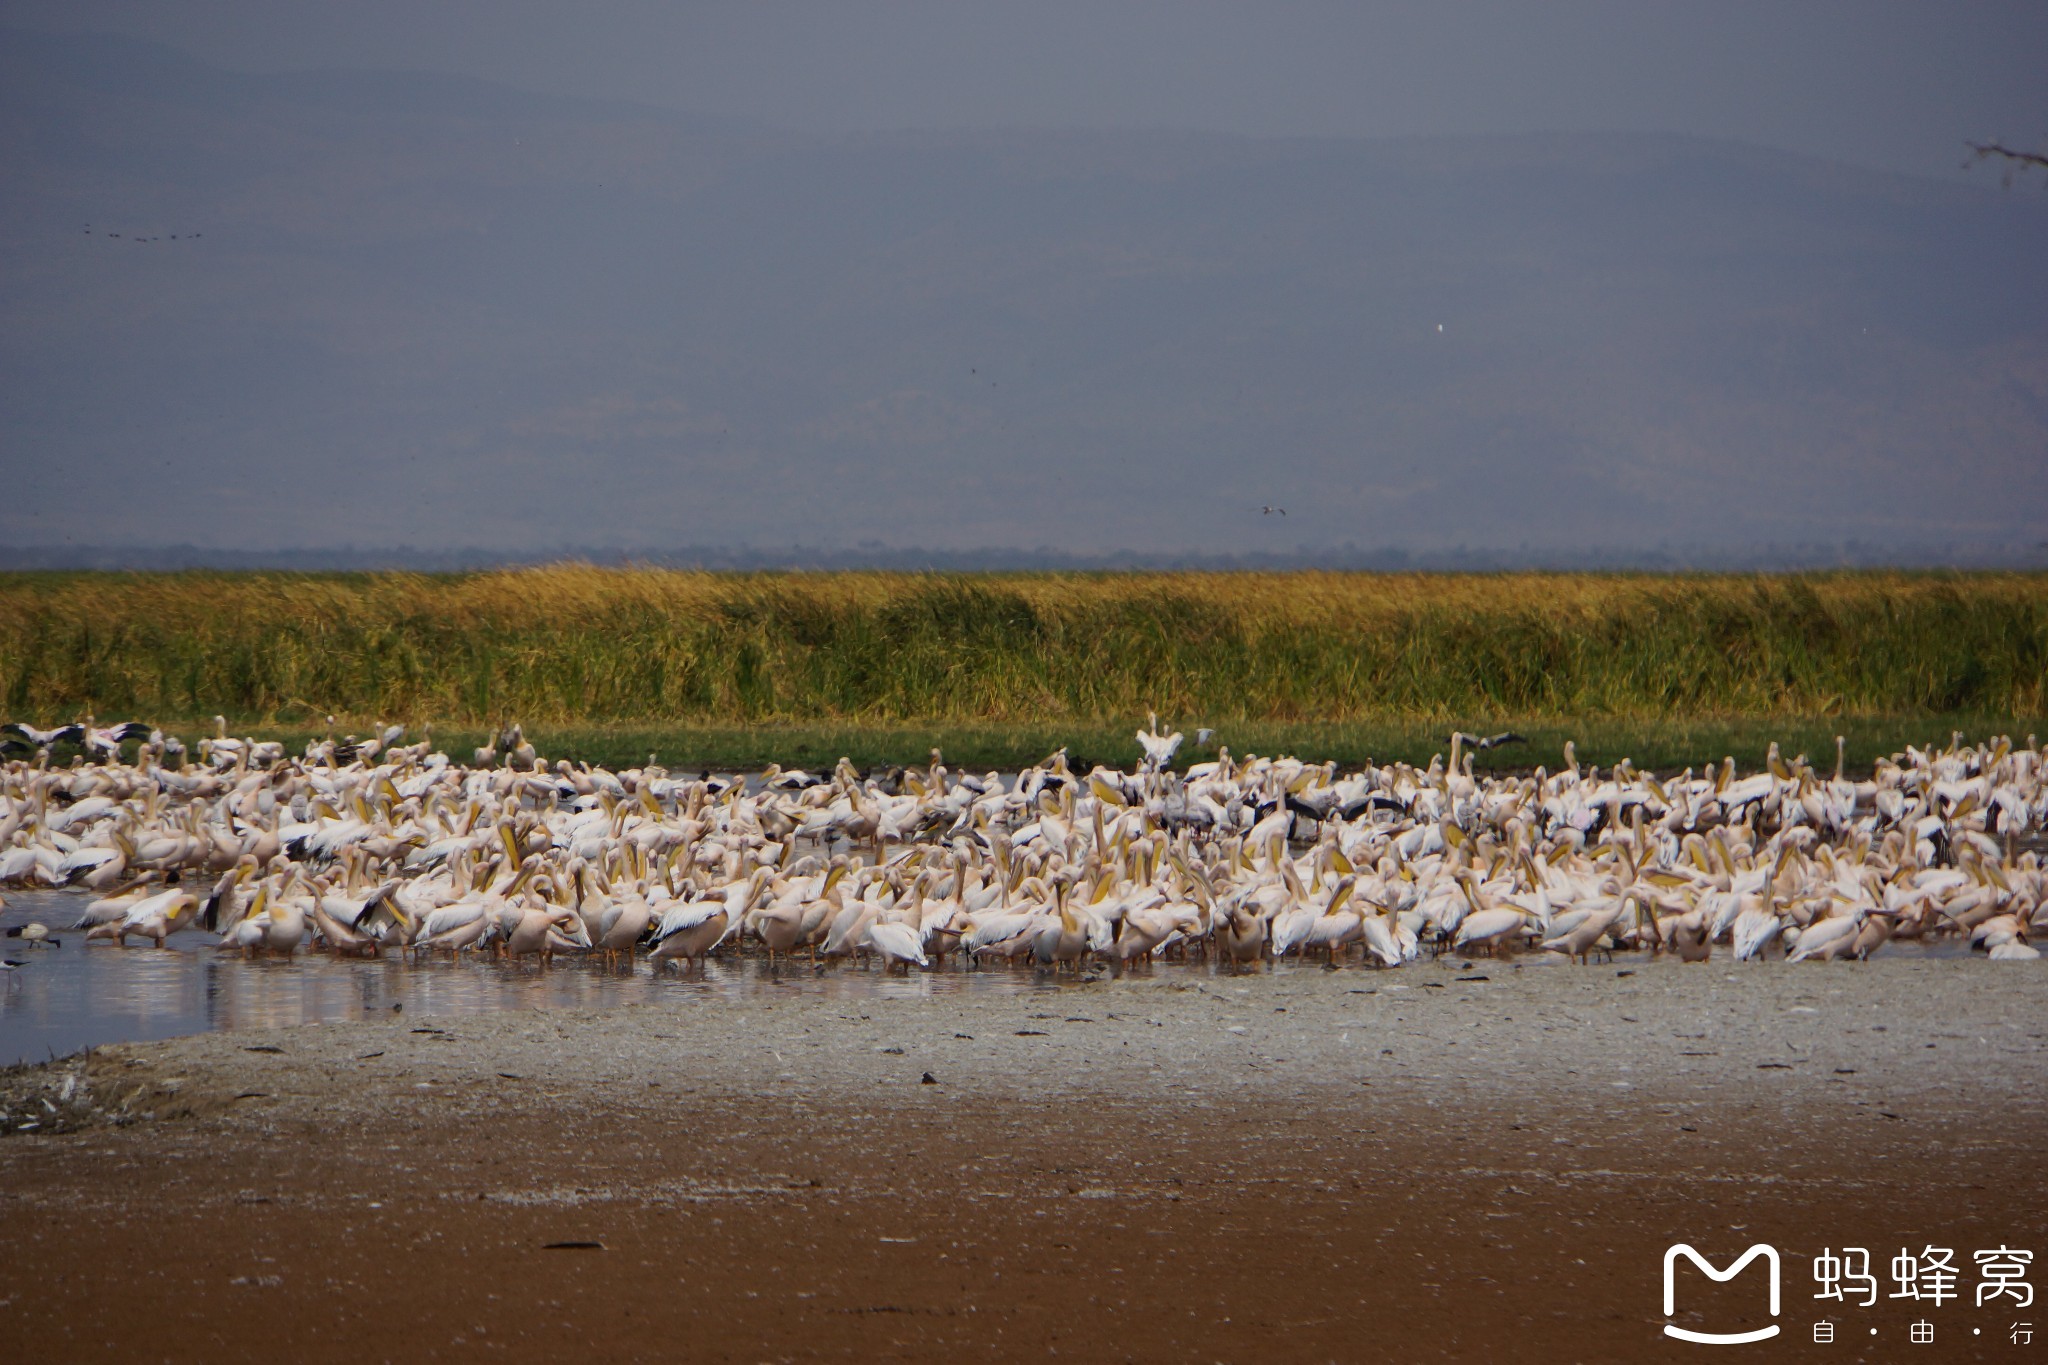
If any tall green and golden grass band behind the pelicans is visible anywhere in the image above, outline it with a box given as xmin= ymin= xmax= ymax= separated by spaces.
xmin=0 ymin=565 xmax=2048 ymax=740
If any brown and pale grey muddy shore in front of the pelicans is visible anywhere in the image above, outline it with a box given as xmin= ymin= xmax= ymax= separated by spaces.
xmin=0 ymin=960 xmax=2048 ymax=1361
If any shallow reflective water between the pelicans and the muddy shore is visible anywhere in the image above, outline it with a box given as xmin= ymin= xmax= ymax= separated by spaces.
xmin=0 ymin=890 xmax=1995 ymax=1066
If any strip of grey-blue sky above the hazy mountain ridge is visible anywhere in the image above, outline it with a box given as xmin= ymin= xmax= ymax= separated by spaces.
xmin=0 ymin=0 xmax=2048 ymax=176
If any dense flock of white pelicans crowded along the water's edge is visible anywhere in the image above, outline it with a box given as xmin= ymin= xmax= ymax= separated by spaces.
xmin=0 ymin=718 xmax=2048 ymax=972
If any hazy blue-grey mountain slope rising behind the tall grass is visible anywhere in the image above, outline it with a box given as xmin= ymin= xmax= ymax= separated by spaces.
xmin=0 ymin=31 xmax=2048 ymax=557
